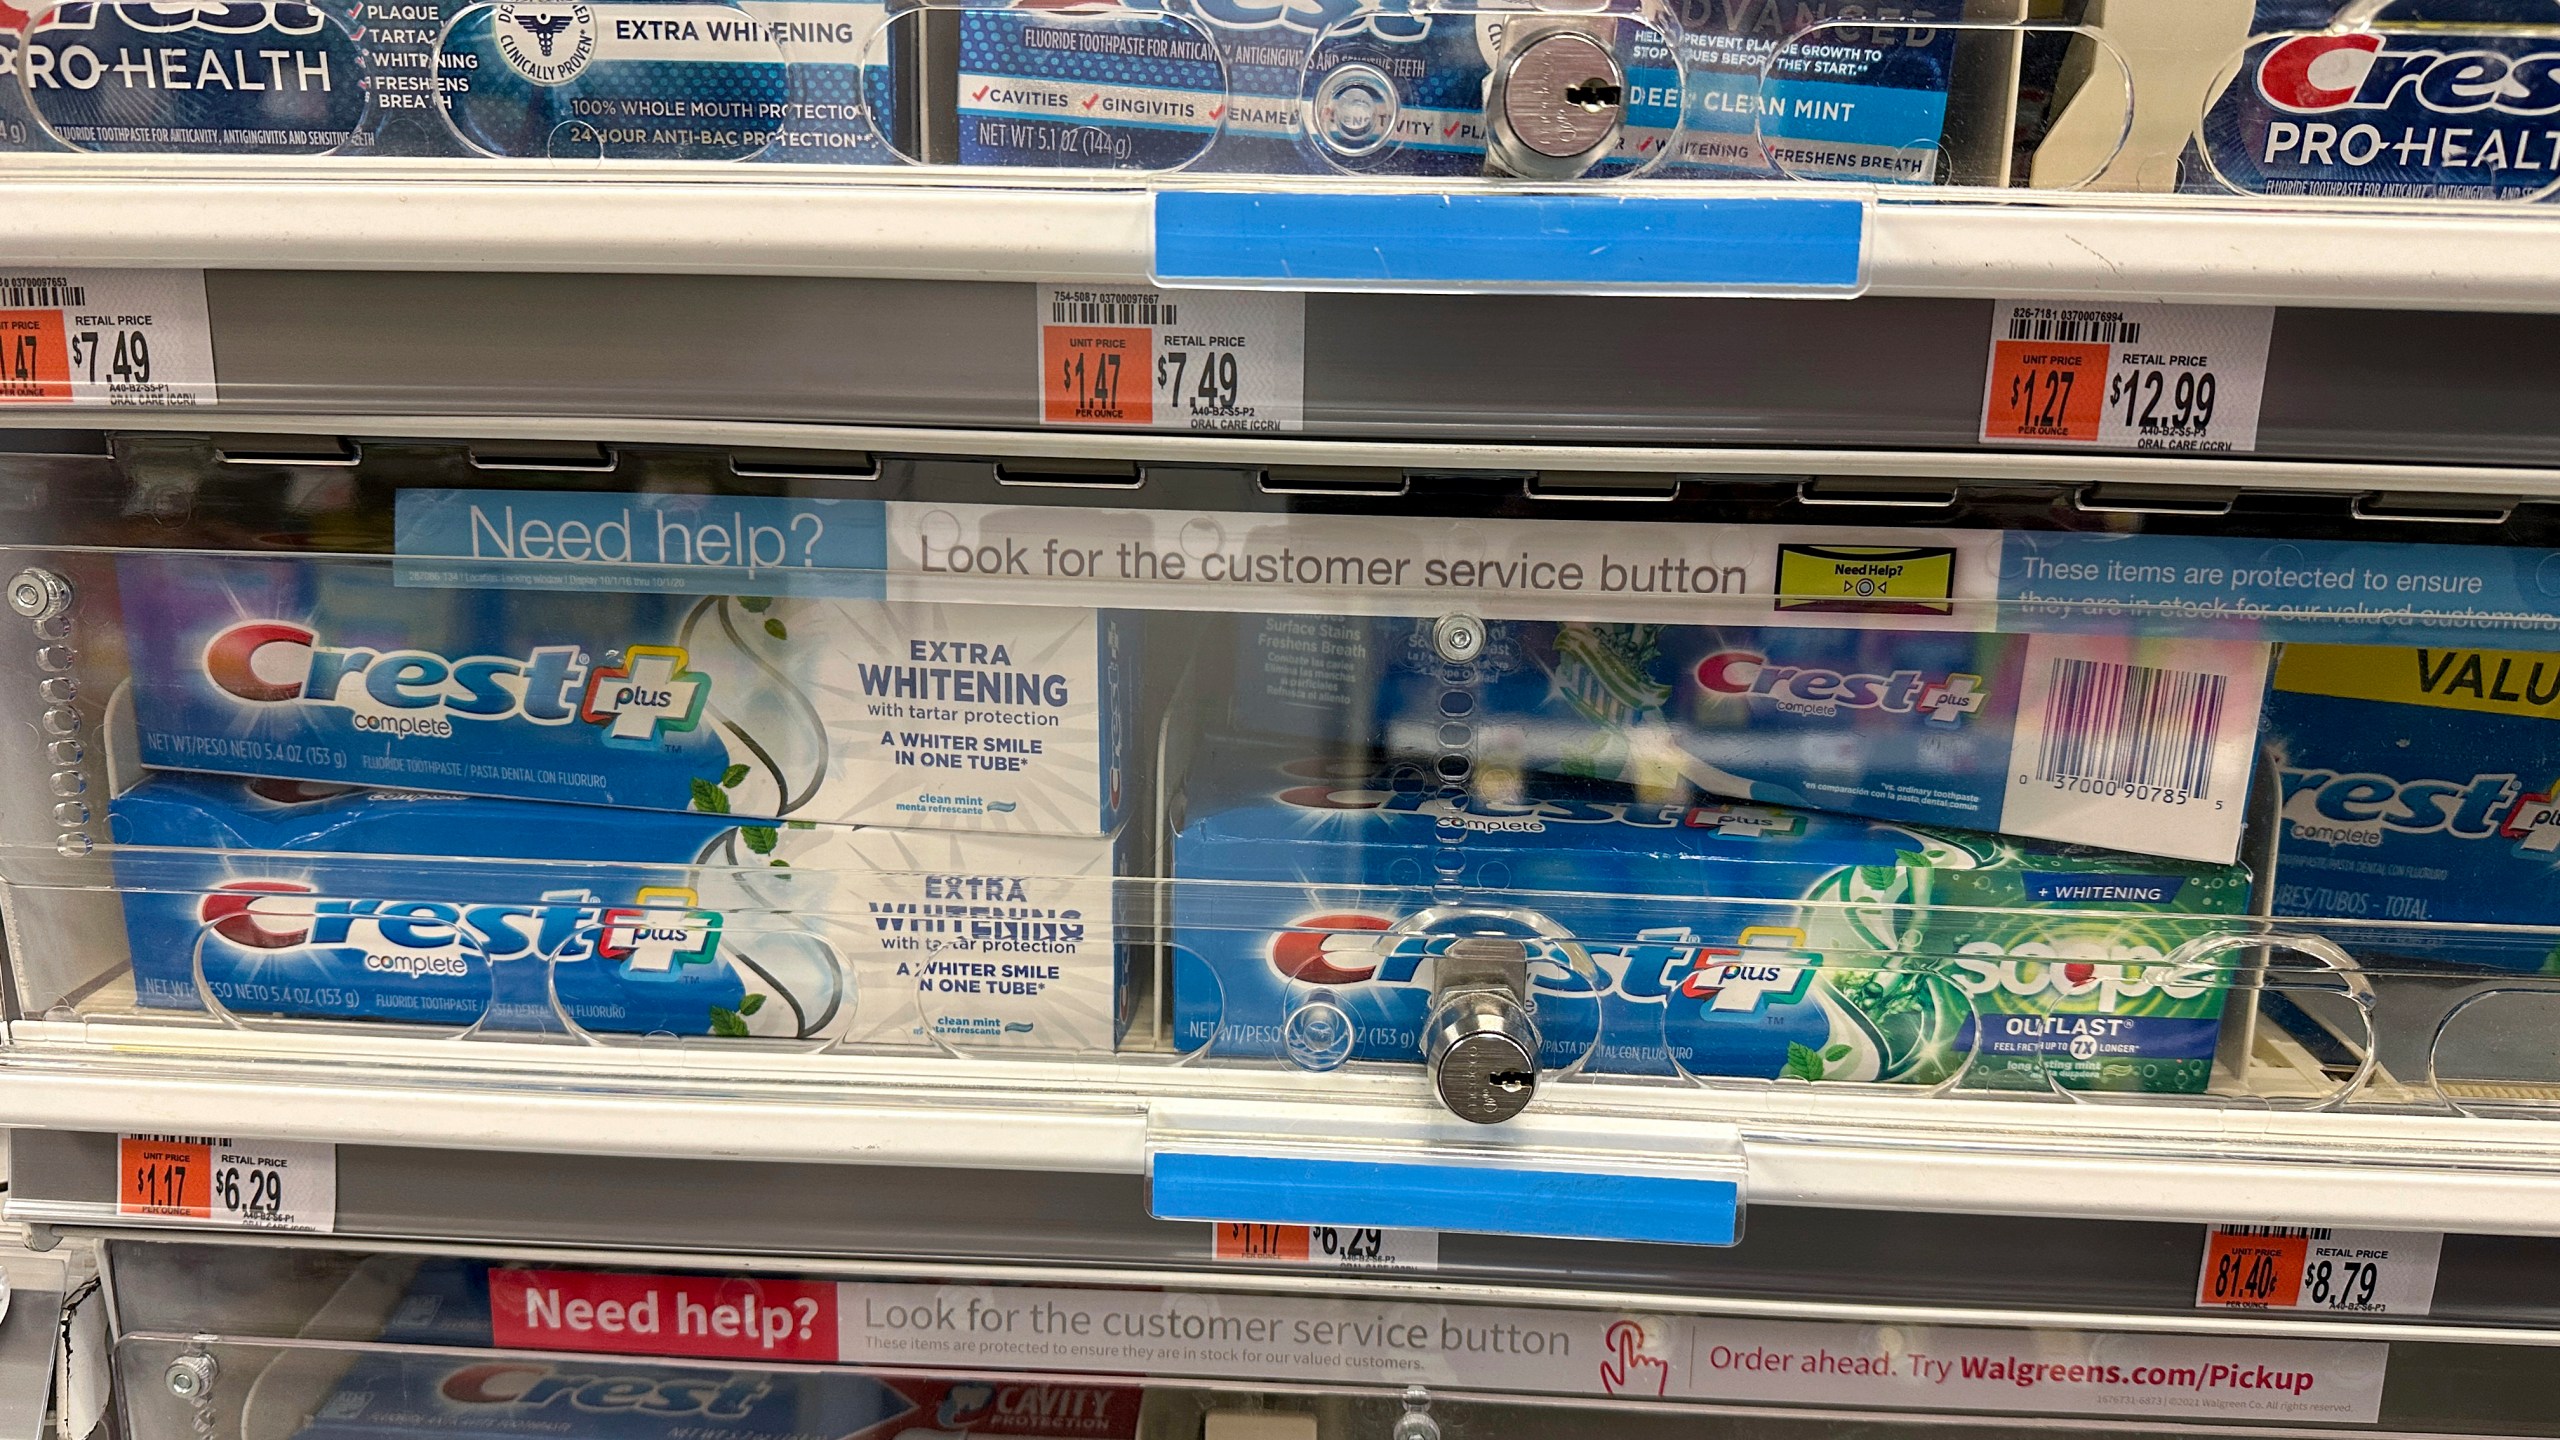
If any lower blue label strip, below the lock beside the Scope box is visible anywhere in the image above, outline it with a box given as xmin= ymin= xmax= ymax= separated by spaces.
xmin=1149 ymin=1150 xmax=1741 ymax=1245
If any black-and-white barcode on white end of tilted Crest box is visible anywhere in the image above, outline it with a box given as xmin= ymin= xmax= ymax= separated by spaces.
xmin=2038 ymin=661 xmax=2230 ymax=799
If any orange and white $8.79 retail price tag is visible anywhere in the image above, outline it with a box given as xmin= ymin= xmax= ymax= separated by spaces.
xmin=2196 ymin=1225 xmax=2445 ymax=1314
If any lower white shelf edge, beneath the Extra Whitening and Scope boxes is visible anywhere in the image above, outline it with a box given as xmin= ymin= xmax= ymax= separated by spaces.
xmin=15 ymin=1022 xmax=2560 ymax=1235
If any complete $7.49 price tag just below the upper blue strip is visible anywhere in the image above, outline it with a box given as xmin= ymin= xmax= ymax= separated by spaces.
xmin=1037 ymin=284 xmax=1306 ymax=433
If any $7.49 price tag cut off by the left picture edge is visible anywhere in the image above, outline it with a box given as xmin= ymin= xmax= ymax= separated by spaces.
xmin=0 ymin=269 xmax=215 ymax=407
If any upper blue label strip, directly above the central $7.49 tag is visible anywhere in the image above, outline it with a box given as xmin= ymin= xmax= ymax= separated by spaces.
xmin=1155 ymin=190 xmax=1866 ymax=295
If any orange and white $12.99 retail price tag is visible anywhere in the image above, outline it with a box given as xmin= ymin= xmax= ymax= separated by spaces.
xmin=1981 ymin=300 xmax=2276 ymax=451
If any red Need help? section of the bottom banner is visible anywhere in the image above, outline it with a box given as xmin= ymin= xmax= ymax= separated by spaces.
xmin=489 ymin=1268 xmax=837 ymax=1363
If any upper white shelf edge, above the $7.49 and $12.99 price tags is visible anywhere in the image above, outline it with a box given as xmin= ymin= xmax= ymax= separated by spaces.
xmin=15 ymin=156 xmax=2560 ymax=310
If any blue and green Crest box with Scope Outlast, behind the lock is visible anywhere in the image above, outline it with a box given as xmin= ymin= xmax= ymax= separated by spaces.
xmin=1172 ymin=743 xmax=2250 ymax=1092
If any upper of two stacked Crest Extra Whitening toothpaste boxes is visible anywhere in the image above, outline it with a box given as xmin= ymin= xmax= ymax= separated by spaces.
xmin=118 ymin=553 xmax=1134 ymax=835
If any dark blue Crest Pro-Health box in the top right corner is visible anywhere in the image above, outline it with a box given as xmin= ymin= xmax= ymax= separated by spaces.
xmin=2184 ymin=0 xmax=2560 ymax=200
